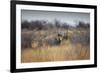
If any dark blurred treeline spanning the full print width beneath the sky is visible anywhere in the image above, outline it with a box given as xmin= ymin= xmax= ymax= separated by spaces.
xmin=21 ymin=20 xmax=90 ymax=30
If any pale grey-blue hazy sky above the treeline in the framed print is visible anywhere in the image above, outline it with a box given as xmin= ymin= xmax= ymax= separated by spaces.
xmin=21 ymin=10 xmax=90 ymax=26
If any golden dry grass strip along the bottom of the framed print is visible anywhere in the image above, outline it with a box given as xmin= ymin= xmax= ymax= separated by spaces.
xmin=21 ymin=40 xmax=90 ymax=63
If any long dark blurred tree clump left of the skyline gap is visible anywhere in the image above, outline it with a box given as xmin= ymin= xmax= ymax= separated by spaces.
xmin=21 ymin=20 xmax=69 ymax=30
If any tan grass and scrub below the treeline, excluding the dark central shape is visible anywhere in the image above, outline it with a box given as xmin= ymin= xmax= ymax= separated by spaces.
xmin=21 ymin=29 xmax=90 ymax=63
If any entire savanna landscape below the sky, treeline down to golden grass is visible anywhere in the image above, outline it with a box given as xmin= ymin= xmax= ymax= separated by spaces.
xmin=21 ymin=19 xmax=90 ymax=63
